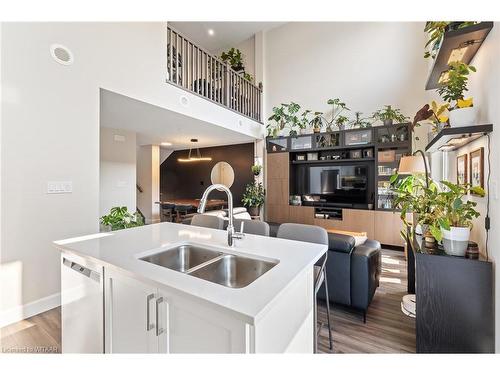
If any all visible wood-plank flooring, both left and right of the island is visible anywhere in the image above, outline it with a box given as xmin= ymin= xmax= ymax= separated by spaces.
xmin=0 ymin=250 xmax=415 ymax=353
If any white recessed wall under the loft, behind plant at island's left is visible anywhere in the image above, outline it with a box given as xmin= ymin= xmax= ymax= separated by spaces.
xmin=99 ymin=127 xmax=137 ymax=216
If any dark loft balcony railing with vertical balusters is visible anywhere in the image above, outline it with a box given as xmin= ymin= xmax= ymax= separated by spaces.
xmin=167 ymin=27 xmax=262 ymax=122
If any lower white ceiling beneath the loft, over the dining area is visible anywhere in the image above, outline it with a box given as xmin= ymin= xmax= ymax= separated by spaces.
xmin=100 ymin=90 xmax=254 ymax=150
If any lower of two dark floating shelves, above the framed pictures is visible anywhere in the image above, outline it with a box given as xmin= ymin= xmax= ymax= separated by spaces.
xmin=425 ymin=124 xmax=493 ymax=152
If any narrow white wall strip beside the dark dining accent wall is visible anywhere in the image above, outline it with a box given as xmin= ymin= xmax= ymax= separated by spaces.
xmin=137 ymin=145 xmax=160 ymax=224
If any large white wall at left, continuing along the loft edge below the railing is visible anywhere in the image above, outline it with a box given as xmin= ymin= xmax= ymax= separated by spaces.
xmin=0 ymin=22 xmax=262 ymax=323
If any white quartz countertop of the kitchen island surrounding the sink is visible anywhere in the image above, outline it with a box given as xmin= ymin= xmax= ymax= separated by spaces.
xmin=54 ymin=223 xmax=328 ymax=323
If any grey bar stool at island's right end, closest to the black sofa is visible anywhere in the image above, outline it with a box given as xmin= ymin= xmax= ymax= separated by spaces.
xmin=276 ymin=223 xmax=333 ymax=352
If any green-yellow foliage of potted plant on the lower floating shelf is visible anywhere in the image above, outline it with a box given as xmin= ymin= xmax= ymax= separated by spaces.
xmin=437 ymin=61 xmax=476 ymax=110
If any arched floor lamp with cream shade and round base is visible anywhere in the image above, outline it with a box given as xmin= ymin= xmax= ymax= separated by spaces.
xmin=398 ymin=150 xmax=429 ymax=318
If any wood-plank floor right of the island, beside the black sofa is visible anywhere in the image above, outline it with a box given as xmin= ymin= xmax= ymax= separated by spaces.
xmin=318 ymin=250 xmax=415 ymax=353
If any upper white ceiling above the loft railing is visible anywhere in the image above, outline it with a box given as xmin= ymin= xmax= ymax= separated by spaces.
xmin=168 ymin=22 xmax=284 ymax=53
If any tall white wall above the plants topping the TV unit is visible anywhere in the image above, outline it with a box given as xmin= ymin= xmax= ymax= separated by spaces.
xmin=264 ymin=22 xmax=429 ymax=147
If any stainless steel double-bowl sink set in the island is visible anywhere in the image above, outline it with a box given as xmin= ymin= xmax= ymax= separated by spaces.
xmin=139 ymin=244 xmax=278 ymax=288
